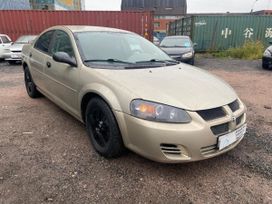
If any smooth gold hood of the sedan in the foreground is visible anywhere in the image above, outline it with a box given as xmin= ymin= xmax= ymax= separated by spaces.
xmin=96 ymin=64 xmax=237 ymax=111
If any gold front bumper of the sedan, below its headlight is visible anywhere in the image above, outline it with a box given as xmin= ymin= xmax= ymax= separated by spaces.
xmin=115 ymin=100 xmax=246 ymax=163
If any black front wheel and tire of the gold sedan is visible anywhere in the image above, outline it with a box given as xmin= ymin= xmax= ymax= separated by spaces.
xmin=85 ymin=98 xmax=125 ymax=158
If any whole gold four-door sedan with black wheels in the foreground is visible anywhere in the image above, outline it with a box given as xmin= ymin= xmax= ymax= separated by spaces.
xmin=23 ymin=26 xmax=246 ymax=163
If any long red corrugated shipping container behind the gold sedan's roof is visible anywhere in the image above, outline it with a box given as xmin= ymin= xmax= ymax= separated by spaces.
xmin=0 ymin=10 xmax=154 ymax=40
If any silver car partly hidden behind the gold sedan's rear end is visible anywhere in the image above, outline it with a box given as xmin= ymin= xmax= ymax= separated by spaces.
xmin=4 ymin=35 xmax=37 ymax=64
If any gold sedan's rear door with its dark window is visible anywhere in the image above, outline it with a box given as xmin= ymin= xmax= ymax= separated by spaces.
xmin=29 ymin=30 xmax=54 ymax=92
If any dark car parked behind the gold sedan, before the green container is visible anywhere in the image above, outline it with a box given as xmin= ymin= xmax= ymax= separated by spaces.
xmin=160 ymin=36 xmax=195 ymax=65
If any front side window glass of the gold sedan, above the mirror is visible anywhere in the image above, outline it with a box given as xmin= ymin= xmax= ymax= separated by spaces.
xmin=52 ymin=30 xmax=75 ymax=57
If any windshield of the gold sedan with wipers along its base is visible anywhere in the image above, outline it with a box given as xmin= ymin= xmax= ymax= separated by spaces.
xmin=75 ymin=31 xmax=173 ymax=67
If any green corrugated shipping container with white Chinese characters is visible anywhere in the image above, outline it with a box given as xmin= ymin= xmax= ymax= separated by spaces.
xmin=169 ymin=16 xmax=272 ymax=51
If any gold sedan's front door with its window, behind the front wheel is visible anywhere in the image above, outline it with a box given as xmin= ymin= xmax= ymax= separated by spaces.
xmin=44 ymin=30 xmax=79 ymax=115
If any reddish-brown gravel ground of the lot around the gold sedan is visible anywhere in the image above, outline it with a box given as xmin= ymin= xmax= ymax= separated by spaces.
xmin=0 ymin=57 xmax=272 ymax=204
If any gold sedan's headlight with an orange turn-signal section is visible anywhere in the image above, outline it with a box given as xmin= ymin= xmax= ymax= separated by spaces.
xmin=130 ymin=99 xmax=192 ymax=123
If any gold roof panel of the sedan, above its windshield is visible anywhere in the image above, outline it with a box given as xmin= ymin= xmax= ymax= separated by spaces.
xmin=50 ymin=25 xmax=132 ymax=33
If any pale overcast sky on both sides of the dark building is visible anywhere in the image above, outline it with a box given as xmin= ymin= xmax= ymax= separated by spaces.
xmin=85 ymin=0 xmax=272 ymax=13
